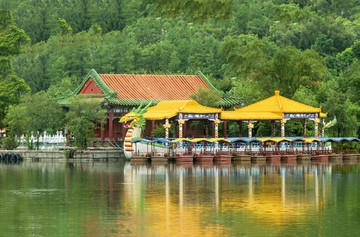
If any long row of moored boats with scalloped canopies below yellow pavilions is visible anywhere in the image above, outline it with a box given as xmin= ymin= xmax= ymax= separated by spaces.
xmin=130 ymin=137 xmax=360 ymax=163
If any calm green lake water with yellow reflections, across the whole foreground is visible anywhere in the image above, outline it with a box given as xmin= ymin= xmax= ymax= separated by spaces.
xmin=0 ymin=162 xmax=360 ymax=237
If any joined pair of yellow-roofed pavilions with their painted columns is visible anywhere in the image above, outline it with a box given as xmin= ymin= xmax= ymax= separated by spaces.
xmin=144 ymin=91 xmax=327 ymax=140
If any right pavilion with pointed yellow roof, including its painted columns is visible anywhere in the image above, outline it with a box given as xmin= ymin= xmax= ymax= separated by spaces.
xmin=220 ymin=91 xmax=327 ymax=137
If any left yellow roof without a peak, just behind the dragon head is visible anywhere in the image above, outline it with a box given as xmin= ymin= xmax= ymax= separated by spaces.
xmin=144 ymin=100 xmax=221 ymax=120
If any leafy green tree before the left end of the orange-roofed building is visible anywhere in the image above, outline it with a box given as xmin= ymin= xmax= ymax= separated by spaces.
xmin=66 ymin=98 xmax=106 ymax=150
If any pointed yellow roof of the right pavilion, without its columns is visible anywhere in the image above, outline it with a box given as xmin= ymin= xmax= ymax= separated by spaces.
xmin=221 ymin=91 xmax=326 ymax=120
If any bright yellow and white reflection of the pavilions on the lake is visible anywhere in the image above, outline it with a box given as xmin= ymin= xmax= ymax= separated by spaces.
xmin=121 ymin=164 xmax=332 ymax=236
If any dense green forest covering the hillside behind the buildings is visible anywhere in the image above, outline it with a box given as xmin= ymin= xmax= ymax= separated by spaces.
xmin=0 ymin=0 xmax=360 ymax=136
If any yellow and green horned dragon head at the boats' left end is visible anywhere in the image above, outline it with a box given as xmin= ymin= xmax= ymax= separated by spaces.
xmin=119 ymin=101 xmax=152 ymax=128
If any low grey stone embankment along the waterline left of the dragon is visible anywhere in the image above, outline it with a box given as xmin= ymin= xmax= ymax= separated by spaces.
xmin=0 ymin=149 xmax=125 ymax=162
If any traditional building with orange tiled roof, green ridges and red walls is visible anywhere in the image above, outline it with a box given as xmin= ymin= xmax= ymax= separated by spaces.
xmin=74 ymin=69 xmax=239 ymax=146
